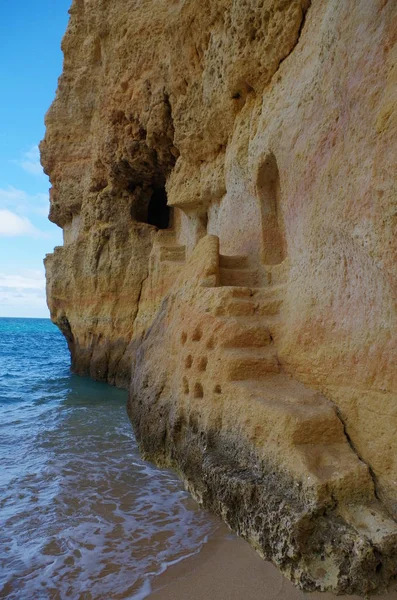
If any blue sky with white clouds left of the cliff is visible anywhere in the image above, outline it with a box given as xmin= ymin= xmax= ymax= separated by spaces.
xmin=0 ymin=0 xmax=71 ymax=317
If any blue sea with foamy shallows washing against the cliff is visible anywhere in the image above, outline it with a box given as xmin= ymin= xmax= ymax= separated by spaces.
xmin=0 ymin=318 xmax=219 ymax=600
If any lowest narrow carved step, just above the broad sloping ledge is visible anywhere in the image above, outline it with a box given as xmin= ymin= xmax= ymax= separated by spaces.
xmin=224 ymin=346 xmax=280 ymax=381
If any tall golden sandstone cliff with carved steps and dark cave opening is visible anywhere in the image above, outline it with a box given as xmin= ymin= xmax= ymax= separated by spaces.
xmin=41 ymin=0 xmax=397 ymax=593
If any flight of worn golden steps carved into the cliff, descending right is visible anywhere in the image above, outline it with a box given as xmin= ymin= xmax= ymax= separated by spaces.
xmin=215 ymin=256 xmax=372 ymax=494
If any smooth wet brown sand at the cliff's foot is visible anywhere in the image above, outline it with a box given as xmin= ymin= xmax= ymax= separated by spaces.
xmin=148 ymin=535 xmax=397 ymax=600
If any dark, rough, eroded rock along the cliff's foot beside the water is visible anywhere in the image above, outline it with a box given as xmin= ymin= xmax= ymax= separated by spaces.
xmin=129 ymin=386 xmax=397 ymax=595
